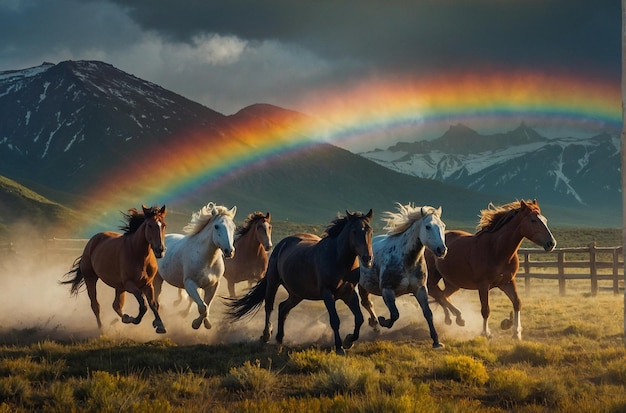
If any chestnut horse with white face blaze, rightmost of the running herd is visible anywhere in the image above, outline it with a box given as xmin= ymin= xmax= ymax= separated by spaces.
xmin=426 ymin=200 xmax=556 ymax=340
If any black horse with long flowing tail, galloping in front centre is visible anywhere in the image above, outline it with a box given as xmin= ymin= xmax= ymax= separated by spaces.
xmin=227 ymin=209 xmax=373 ymax=355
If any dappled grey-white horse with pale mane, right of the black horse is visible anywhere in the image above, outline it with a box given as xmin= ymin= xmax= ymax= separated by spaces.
xmin=355 ymin=203 xmax=447 ymax=348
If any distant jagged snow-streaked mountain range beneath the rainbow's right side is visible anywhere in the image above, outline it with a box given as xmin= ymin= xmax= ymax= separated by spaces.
xmin=361 ymin=124 xmax=622 ymax=226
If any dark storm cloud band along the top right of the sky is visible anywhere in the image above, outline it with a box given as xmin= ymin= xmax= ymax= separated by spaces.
xmin=103 ymin=0 xmax=621 ymax=76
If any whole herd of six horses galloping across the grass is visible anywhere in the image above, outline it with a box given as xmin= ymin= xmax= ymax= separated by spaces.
xmin=62 ymin=200 xmax=556 ymax=354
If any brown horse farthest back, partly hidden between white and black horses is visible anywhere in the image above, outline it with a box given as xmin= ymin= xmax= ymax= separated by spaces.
xmin=224 ymin=212 xmax=272 ymax=297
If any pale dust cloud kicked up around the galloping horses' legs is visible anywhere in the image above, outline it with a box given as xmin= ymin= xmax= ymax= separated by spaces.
xmin=0 ymin=229 xmax=500 ymax=348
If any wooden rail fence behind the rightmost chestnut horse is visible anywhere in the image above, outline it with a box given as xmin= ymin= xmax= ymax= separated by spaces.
xmin=517 ymin=242 xmax=624 ymax=295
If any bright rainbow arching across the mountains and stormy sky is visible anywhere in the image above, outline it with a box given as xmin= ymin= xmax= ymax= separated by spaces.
xmin=73 ymin=72 xmax=622 ymax=236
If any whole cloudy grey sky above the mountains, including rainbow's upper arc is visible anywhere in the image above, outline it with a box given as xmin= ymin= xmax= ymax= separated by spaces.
xmin=0 ymin=0 xmax=621 ymax=149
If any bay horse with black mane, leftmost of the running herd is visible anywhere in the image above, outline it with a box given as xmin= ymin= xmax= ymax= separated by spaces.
xmin=61 ymin=205 xmax=166 ymax=334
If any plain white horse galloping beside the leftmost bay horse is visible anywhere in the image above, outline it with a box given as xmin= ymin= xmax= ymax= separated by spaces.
xmin=154 ymin=202 xmax=237 ymax=329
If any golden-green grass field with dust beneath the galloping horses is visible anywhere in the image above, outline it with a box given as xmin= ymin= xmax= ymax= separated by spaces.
xmin=0 ymin=230 xmax=626 ymax=413
